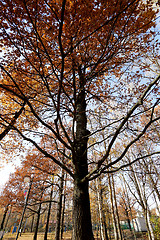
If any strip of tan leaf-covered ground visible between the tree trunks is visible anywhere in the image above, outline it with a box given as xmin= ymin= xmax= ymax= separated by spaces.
xmin=3 ymin=231 xmax=148 ymax=240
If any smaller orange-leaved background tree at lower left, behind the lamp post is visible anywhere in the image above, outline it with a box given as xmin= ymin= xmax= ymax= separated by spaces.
xmin=0 ymin=161 xmax=57 ymax=236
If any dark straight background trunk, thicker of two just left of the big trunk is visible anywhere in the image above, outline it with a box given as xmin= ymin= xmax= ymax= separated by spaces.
xmin=55 ymin=170 xmax=64 ymax=240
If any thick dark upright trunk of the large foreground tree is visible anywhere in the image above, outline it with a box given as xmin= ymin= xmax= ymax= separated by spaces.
xmin=72 ymin=68 xmax=94 ymax=240
